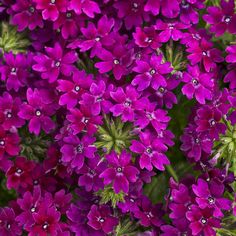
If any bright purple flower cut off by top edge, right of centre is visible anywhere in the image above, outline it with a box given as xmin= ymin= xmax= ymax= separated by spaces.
xmin=144 ymin=0 xmax=180 ymax=18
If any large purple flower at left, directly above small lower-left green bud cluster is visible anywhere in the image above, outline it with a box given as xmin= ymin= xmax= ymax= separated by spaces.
xmin=18 ymin=88 xmax=57 ymax=135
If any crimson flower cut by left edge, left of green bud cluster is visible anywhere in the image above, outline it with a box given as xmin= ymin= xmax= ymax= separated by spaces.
xmin=0 ymin=126 xmax=20 ymax=158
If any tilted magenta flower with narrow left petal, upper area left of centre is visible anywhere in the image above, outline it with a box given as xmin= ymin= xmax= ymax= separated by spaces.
xmin=77 ymin=15 xmax=115 ymax=57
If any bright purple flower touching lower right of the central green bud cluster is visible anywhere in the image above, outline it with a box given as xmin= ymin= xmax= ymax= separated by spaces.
xmin=130 ymin=132 xmax=170 ymax=171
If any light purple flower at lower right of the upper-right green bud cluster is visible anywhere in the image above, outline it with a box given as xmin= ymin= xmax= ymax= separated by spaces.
xmin=182 ymin=65 xmax=214 ymax=104
